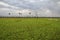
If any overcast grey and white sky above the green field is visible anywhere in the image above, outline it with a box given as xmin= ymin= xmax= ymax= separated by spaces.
xmin=0 ymin=0 xmax=60 ymax=17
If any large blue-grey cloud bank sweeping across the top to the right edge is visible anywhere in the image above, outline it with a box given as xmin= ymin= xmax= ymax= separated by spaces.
xmin=0 ymin=0 xmax=60 ymax=15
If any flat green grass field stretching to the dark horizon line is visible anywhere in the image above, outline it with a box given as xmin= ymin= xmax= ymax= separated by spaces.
xmin=0 ymin=18 xmax=60 ymax=40
